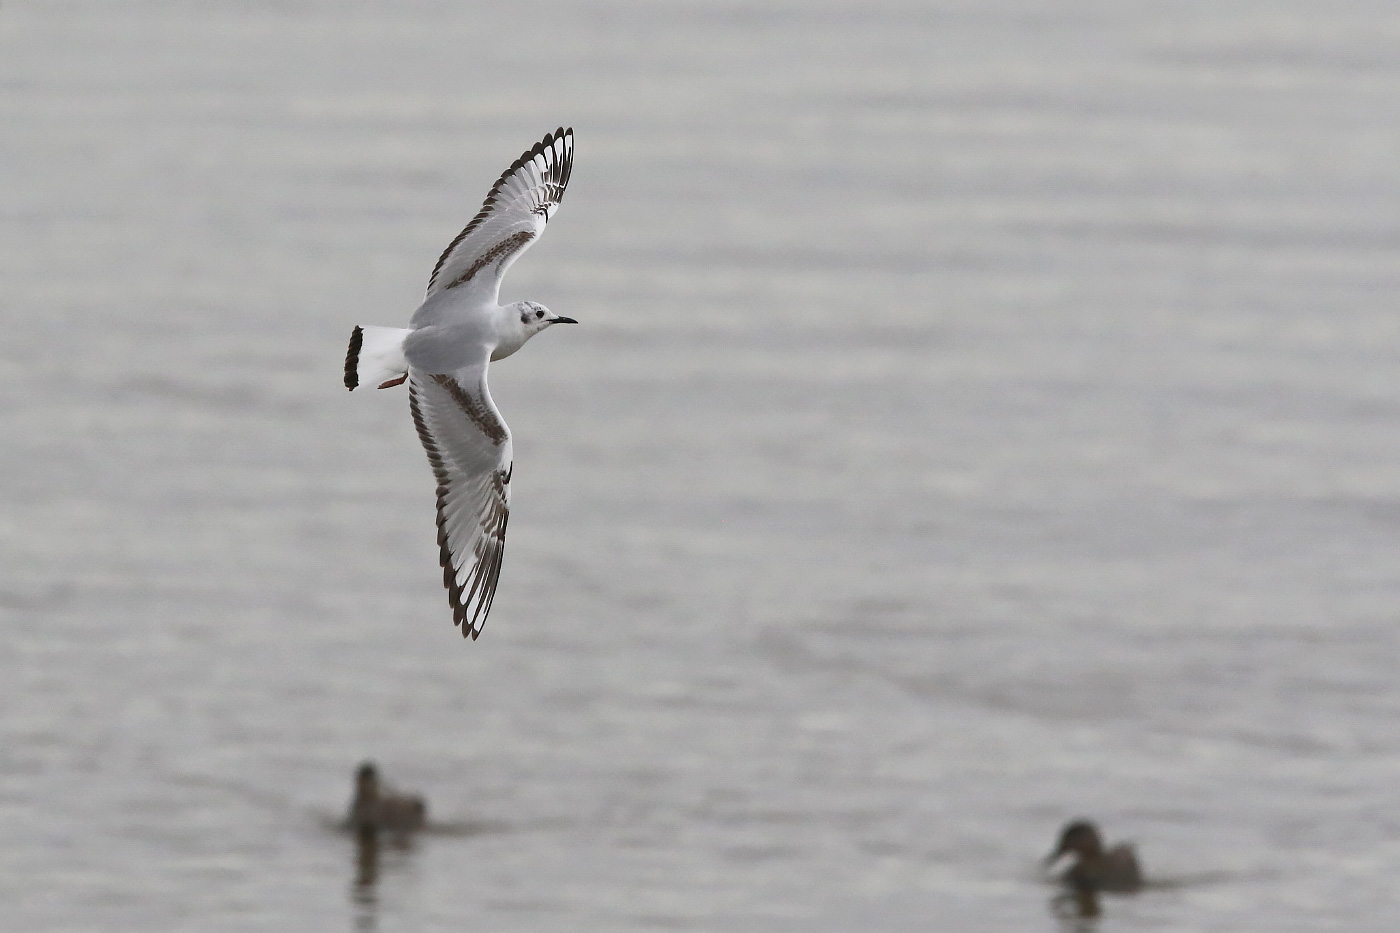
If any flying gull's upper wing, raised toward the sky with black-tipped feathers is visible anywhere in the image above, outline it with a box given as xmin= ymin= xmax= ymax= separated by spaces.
xmin=428 ymin=127 xmax=574 ymax=304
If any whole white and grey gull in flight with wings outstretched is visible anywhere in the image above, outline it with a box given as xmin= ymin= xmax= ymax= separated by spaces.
xmin=344 ymin=129 xmax=577 ymax=639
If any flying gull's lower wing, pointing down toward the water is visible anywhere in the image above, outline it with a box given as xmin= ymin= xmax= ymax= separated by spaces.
xmin=409 ymin=359 xmax=512 ymax=639
